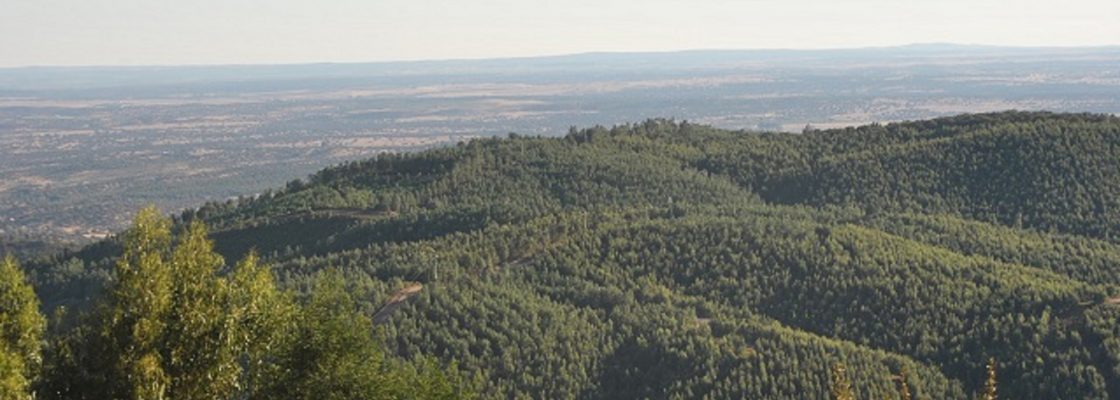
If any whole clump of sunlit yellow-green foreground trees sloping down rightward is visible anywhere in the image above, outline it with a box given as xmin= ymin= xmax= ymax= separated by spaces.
xmin=32 ymin=207 xmax=468 ymax=399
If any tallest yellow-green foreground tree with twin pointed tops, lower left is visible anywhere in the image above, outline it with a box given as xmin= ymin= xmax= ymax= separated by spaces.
xmin=81 ymin=207 xmax=242 ymax=399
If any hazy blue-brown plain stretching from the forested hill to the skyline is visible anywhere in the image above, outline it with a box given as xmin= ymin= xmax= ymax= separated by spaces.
xmin=0 ymin=45 xmax=1120 ymax=242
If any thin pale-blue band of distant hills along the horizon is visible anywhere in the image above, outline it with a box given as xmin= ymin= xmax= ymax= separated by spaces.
xmin=0 ymin=44 xmax=1120 ymax=94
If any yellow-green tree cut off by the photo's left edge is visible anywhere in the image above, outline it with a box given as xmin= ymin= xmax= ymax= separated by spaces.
xmin=0 ymin=255 xmax=46 ymax=400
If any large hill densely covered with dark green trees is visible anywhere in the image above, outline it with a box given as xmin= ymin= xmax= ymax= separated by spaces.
xmin=32 ymin=112 xmax=1120 ymax=399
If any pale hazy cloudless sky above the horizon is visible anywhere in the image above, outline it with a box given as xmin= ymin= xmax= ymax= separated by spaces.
xmin=0 ymin=0 xmax=1120 ymax=67
